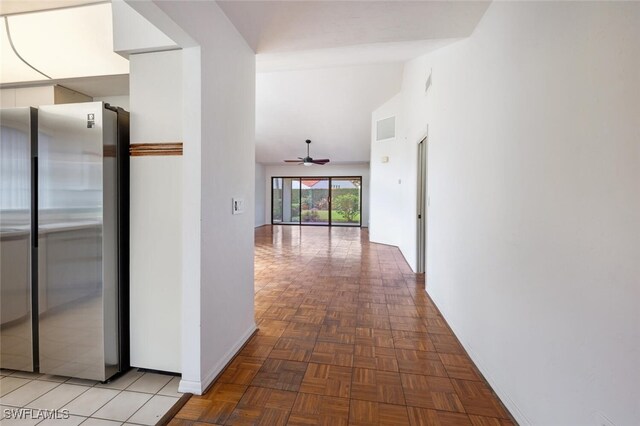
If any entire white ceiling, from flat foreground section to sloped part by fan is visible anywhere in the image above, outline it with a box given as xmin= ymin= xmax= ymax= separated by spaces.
xmin=235 ymin=0 xmax=489 ymax=164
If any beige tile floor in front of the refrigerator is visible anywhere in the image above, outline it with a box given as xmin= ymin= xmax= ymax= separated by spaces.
xmin=0 ymin=369 xmax=182 ymax=426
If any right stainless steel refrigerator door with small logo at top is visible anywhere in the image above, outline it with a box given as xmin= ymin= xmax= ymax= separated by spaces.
xmin=38 ymin=102 xmax=118 ymax=380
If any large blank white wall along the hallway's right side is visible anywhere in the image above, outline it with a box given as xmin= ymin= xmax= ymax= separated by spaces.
xmin=371 ymin=2 xmax=640 ymax=425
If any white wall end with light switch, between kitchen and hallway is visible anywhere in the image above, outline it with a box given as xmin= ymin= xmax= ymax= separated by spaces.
xmin=151 ymin=1 xmax=256 ymax=393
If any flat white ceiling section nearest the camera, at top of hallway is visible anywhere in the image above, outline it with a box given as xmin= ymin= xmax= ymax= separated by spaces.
xmin=218 ymin=1 xmax=489 ymax=53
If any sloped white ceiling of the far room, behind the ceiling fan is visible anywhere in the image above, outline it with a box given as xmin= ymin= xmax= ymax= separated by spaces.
xmin=256 ymin=63 xmax=403 ymax=164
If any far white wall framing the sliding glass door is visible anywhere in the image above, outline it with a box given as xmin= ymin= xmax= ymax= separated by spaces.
xmin=263 ymin=164 xmax=369 ymax=227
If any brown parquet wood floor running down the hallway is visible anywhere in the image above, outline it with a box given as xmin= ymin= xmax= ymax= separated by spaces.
xmin=171 ymin=226 xmax=513 ymax=426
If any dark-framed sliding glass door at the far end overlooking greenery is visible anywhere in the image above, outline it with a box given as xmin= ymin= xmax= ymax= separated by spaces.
xmin=271 ymin=177 xmax=362 ymax=226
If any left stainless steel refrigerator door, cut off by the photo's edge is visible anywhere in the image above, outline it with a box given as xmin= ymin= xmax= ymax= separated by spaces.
xmin=0 ymin=108 xmax=36 ymax=371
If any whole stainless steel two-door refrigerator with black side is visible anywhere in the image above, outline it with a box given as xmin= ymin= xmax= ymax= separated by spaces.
xmin=0 ymin=102 xmax=129 ymax=381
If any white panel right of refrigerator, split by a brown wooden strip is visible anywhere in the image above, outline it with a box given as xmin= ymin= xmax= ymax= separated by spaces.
xmin=129 ymin=50 xmax=183 ymax=372
